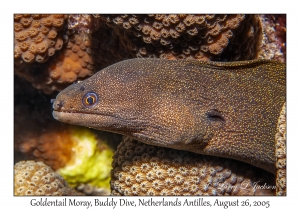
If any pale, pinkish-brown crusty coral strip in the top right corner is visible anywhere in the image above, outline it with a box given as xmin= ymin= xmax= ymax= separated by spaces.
xmin=258 ymin=14 xmax=286 ymax=62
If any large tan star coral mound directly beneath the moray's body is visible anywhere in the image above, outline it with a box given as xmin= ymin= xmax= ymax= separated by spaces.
xmin=111 ymin=138 xmax=275 ymax=195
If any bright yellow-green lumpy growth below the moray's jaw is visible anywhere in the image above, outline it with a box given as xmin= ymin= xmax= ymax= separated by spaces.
xmin=58 ymin=128 xmax=113 ymax=190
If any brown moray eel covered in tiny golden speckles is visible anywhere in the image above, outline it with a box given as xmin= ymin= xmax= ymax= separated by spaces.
xmin=53 ymin=59 xmax=286 ymax=173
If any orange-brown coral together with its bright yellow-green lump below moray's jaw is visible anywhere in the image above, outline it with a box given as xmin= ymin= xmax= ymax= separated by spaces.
xmin=15 ymin=121 xmax=113 ymax=190
